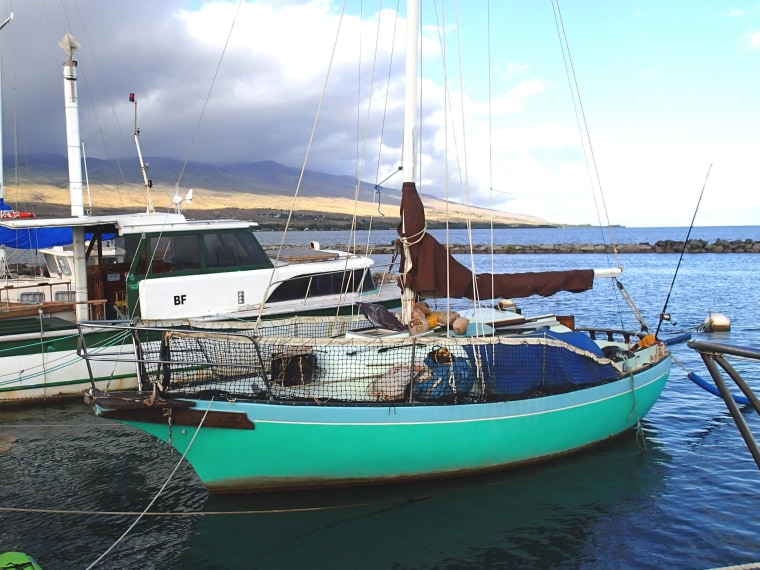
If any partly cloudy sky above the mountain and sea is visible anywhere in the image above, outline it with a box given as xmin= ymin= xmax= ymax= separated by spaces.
xmin=0 ymin=0 xmax=760 ymax=227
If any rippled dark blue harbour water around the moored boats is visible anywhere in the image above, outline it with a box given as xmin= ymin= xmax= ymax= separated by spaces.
xmin=0 ymin=227 xmax=760 ymax=570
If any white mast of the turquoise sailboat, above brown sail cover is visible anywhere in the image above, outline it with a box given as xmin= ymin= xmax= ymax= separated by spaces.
xmin=401 ymin=0 xmax=420 ymax=324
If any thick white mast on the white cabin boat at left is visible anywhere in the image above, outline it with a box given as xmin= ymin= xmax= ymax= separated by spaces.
xmin=58 ymin=34 xmax=89 ymax=320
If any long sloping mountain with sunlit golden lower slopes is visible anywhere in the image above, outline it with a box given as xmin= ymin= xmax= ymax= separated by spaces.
xmin=5 ymin=154 xmax=552 ymax=229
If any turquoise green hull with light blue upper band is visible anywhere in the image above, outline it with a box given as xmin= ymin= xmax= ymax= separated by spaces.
xmin=110 ymin=357 xmax=670 ymax=493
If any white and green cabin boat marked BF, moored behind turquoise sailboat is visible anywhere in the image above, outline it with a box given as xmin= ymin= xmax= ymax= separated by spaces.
xmin=0 ymin=34 xmax=400 ymax=405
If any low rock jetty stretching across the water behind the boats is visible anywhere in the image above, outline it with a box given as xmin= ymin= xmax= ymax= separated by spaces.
xmin=267 ymin=239 xmax=760 ymax=254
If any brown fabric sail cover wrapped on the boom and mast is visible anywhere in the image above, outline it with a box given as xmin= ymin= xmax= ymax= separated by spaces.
xmin=398 ymin=182 xmax=594 ymax=299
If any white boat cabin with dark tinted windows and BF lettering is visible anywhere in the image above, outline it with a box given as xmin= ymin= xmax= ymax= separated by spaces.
xmin=0 ymin=214 xmax=388 ymax=319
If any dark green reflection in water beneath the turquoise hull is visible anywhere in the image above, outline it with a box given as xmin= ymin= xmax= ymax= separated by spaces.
xmin=178 ymin=433 xmax=668 ymax=568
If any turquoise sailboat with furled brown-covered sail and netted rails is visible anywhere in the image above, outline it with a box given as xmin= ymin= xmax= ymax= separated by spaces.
xmin=80 ymin=2 xmax=671 ymax=493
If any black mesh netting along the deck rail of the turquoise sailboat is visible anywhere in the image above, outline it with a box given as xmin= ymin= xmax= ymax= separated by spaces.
xmin=126 ymin=317 xmax=620 ymax=404
